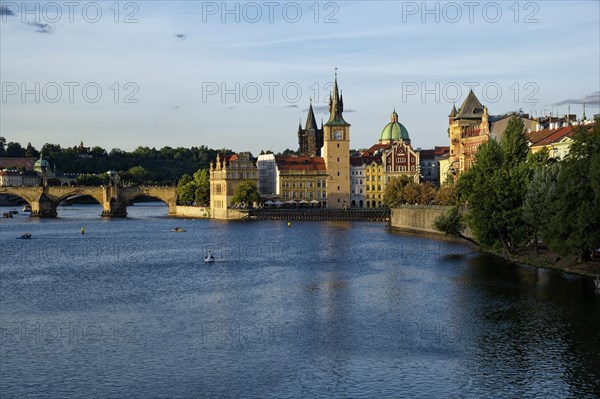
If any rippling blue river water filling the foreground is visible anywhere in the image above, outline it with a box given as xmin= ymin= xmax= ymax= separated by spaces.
xmin=0 ymin=204 xmax=600 ymax=399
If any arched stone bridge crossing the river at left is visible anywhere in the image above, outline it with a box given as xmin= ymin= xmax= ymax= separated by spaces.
xmin=0 ymin=186 xmax=177 ymax=217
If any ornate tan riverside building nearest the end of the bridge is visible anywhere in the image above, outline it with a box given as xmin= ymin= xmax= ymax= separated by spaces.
xmin=210 ymin=152 xmax=258 ymax=219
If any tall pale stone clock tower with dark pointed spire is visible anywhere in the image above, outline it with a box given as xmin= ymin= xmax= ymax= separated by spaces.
xmin=322 ymin=72 xmax=350 ymax=208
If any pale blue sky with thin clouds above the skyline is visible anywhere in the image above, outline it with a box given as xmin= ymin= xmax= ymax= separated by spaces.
xmin=0 ymin=0 xmax=600 ymax=154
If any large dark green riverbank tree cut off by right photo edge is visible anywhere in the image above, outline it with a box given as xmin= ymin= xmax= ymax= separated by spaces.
xmin=541 ymin=118 xmax=600 ymax=262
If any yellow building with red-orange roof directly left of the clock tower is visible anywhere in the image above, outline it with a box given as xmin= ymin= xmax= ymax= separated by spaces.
xmin=275 ymin=156 xmax=328 ymax=206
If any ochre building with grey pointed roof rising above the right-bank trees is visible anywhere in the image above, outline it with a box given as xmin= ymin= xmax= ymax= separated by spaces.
xmin=448 ymin=90 xmax=490 ymax=173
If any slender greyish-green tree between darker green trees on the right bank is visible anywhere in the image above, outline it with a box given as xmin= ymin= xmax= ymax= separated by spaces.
xmin=523 ymin=164 xmax=560 ymax=253
